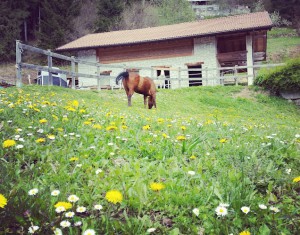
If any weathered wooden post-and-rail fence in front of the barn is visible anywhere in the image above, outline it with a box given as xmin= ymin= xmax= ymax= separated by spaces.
xmin=16 ymin=41 xmax=284 ymax=90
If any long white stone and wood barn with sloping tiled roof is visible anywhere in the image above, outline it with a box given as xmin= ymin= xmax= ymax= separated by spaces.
xmin=56 ymin=12 xmax=272 ymax=88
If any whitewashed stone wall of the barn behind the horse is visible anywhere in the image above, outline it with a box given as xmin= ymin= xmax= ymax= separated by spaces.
xmin=78 ymin=37 xmax=218 ymax=88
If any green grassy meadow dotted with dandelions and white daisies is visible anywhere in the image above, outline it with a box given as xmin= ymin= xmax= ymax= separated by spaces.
xmin=0 ymin=86 xmax=300 ymax=235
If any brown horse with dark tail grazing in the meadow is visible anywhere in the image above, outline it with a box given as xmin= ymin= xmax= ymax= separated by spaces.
xmin=116 ymin=72 xmax=156 ymax=109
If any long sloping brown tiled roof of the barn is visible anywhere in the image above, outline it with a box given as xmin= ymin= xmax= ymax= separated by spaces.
xmin=56 ymin=11 xmax=272 ymax=51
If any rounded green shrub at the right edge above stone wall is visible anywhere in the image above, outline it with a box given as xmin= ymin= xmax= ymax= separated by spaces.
xmin=254 ymin=57 xmax=300 ymax=94
